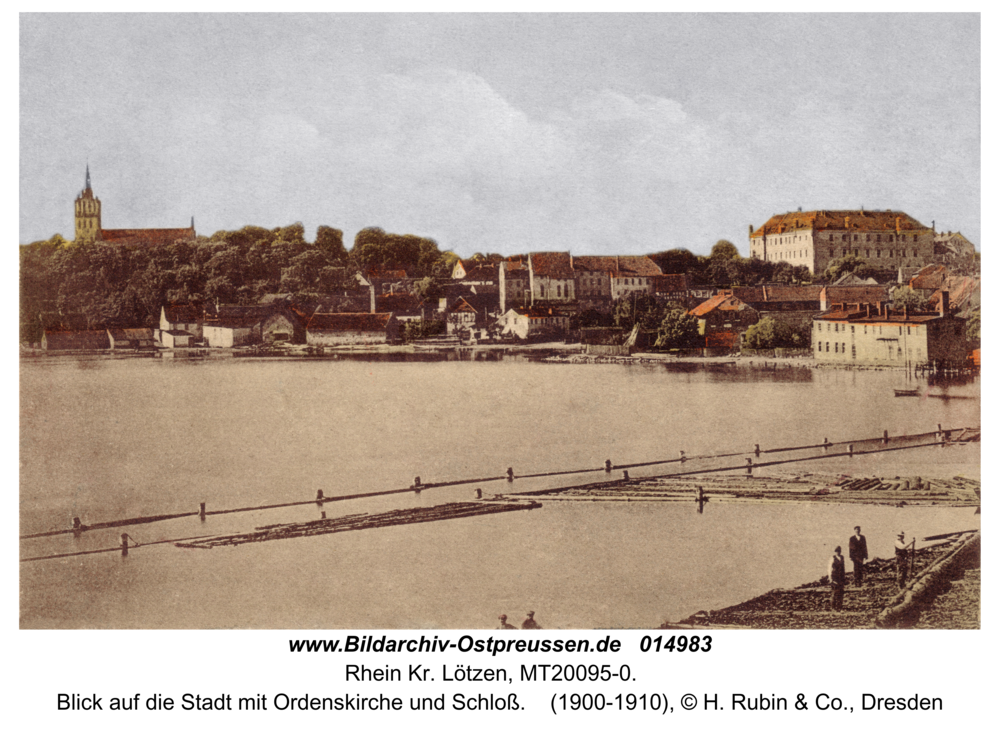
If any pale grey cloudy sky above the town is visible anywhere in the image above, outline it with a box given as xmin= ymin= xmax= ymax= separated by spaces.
xmin=19 ymin=14 xmax=981 ymax=256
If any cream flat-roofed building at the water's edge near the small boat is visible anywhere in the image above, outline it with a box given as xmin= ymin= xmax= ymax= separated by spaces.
xmin=811 ymin=292 xmax=967 ymax=367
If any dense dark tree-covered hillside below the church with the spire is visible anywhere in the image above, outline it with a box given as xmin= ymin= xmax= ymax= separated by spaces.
xmin=20 ymin=223 xmax=457 ymax=342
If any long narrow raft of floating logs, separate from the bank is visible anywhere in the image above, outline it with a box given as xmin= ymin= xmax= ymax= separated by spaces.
xmin=175 ymin=501 xmax=542 ymax=549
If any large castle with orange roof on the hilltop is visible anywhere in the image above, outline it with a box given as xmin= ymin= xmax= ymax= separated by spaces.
xmin=750 ymin=209 xmax=935 ymax=274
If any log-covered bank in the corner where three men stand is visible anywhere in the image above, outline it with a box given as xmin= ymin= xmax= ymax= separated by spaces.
xmin=660 ymin=530 xmax=981 ymax=630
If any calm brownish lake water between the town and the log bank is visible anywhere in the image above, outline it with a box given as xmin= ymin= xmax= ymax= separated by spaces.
xmin=20 ymin=357 xmax=980 ymax=628
